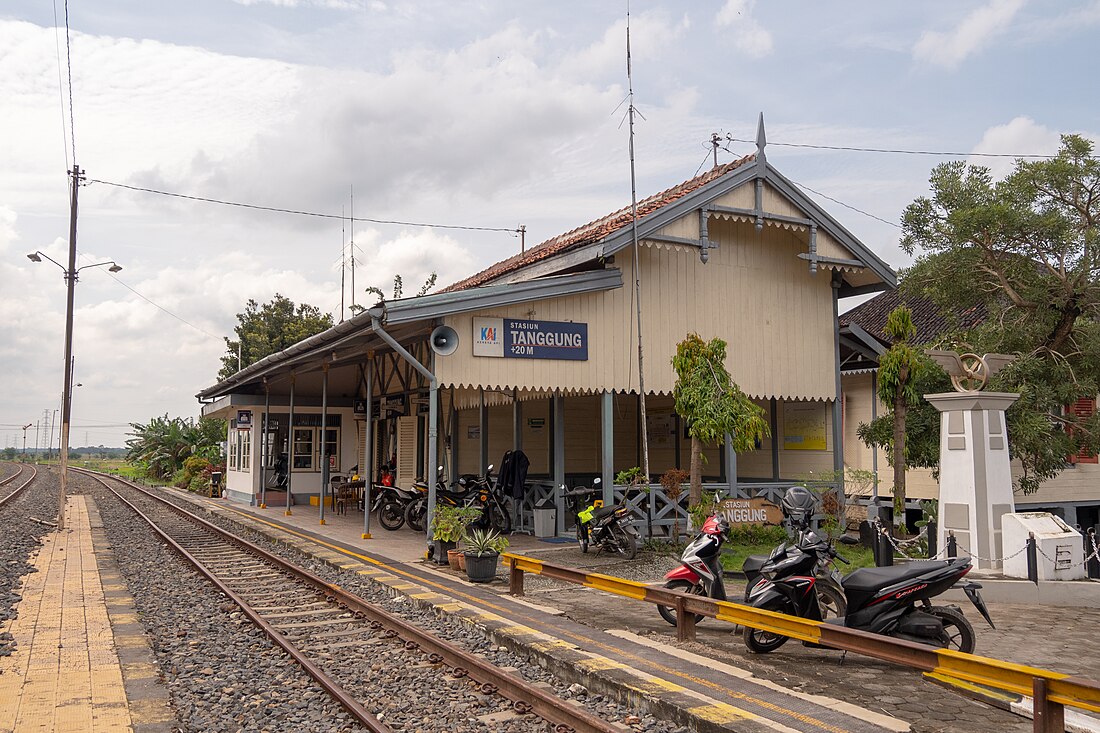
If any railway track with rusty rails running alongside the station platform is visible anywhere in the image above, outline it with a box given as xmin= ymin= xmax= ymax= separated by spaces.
xmin=80 ymin=471 xmax=620 ymax=733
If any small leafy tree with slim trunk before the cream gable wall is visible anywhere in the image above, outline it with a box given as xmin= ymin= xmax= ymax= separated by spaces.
xmin=672 ymin=333 xmax=770 ymax=506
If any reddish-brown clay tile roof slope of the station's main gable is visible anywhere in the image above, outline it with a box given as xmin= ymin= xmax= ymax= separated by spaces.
xmin=440 ymin=155 xmax=756 ymax=293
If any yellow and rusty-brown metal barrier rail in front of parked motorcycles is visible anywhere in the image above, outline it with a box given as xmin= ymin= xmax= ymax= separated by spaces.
xmin=504 ymin=553 xmax=1100 ymax=733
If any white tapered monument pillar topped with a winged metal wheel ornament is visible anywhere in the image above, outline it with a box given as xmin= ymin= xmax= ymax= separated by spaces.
xmin=924 ymin=351 xmax=1020 ymax=569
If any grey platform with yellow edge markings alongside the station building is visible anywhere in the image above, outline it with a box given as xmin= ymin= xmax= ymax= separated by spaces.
xmin=171 ymin=490 xmax=910 ymax=733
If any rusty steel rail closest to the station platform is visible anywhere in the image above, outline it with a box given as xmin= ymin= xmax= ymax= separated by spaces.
xmin=81 ymin=472 xmax=620 ymax=733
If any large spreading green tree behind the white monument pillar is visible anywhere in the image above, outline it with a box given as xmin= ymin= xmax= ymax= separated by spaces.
xmin=902 ymin=135 xmax=1100 ymax=492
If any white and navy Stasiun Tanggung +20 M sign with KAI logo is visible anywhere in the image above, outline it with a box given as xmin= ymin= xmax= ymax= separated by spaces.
xmin=473 ymin=318 xmax=589 ymax=361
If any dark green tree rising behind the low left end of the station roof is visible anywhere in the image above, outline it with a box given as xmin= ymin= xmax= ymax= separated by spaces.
xmin=218 ymin=293 xmax=332 ymax=380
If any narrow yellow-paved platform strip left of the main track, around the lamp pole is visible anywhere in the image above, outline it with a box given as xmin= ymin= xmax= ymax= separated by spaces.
xmin=0 ymin=495 xmax=175 ymax=733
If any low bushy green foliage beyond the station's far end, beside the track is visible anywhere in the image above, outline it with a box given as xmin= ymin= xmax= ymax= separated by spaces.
xmin=127 ymin=415 xmax=226 ymax=479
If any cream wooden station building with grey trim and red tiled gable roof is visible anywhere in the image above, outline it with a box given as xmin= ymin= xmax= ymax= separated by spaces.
xmin=198 ymin=124 xmax=897 ymax=532
